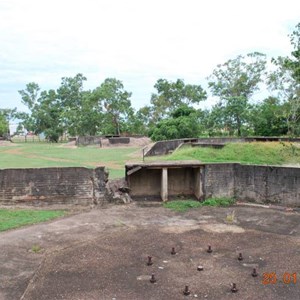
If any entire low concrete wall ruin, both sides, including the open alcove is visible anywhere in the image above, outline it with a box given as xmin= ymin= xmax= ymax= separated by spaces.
xmin=0 ymin=161 xmax=300 ymax=207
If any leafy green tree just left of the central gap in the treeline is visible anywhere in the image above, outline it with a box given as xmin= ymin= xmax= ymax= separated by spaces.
xmin=94 ymin=78 xmax=133 ymax=135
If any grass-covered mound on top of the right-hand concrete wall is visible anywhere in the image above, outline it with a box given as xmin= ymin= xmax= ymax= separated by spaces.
xmin=151 ymin=142 xmax=300 ymax=165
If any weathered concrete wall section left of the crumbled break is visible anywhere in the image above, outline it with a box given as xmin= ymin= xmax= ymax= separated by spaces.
xmin=0 ymin=167 xmax=107 ymax=205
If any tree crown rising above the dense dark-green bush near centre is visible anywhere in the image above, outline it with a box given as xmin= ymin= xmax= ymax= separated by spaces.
xmin=151 ymin=79 xmax=207 ymax=123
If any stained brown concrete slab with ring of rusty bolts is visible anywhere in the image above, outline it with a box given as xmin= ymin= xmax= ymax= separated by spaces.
xmin=0 ymin=203 xmax=300 ymax=300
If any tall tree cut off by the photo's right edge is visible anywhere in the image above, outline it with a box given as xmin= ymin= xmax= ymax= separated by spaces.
xmin=269 ymin=23 xmax=300 ymax=135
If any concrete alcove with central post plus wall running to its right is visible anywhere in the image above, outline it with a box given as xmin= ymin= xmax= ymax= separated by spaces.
xmin=125 ymin=161 xmax=300 ymax=207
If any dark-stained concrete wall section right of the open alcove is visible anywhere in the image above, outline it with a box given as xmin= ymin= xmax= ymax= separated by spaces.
xmin=203 ymin=164 xmax=300 ymax=207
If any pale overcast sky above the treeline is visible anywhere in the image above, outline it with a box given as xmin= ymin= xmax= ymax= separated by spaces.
xmin=0 ymin=0 xmax=300 ymax=110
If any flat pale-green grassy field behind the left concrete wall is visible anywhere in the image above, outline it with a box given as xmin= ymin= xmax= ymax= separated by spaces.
xmin=0 ymin=143 xmax=141 ymax=178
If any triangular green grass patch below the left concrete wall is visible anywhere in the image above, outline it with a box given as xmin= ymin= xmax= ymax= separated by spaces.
xmin=0 ymin=209 xmax=66 ymax=231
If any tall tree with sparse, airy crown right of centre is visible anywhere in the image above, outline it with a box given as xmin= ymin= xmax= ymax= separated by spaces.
xmin=208 ymin=52 xmax=266 ymax=136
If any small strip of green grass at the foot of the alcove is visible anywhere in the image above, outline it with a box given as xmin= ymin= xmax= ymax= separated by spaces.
xmin=163 ymin=198 xmax=235 ymax=212
